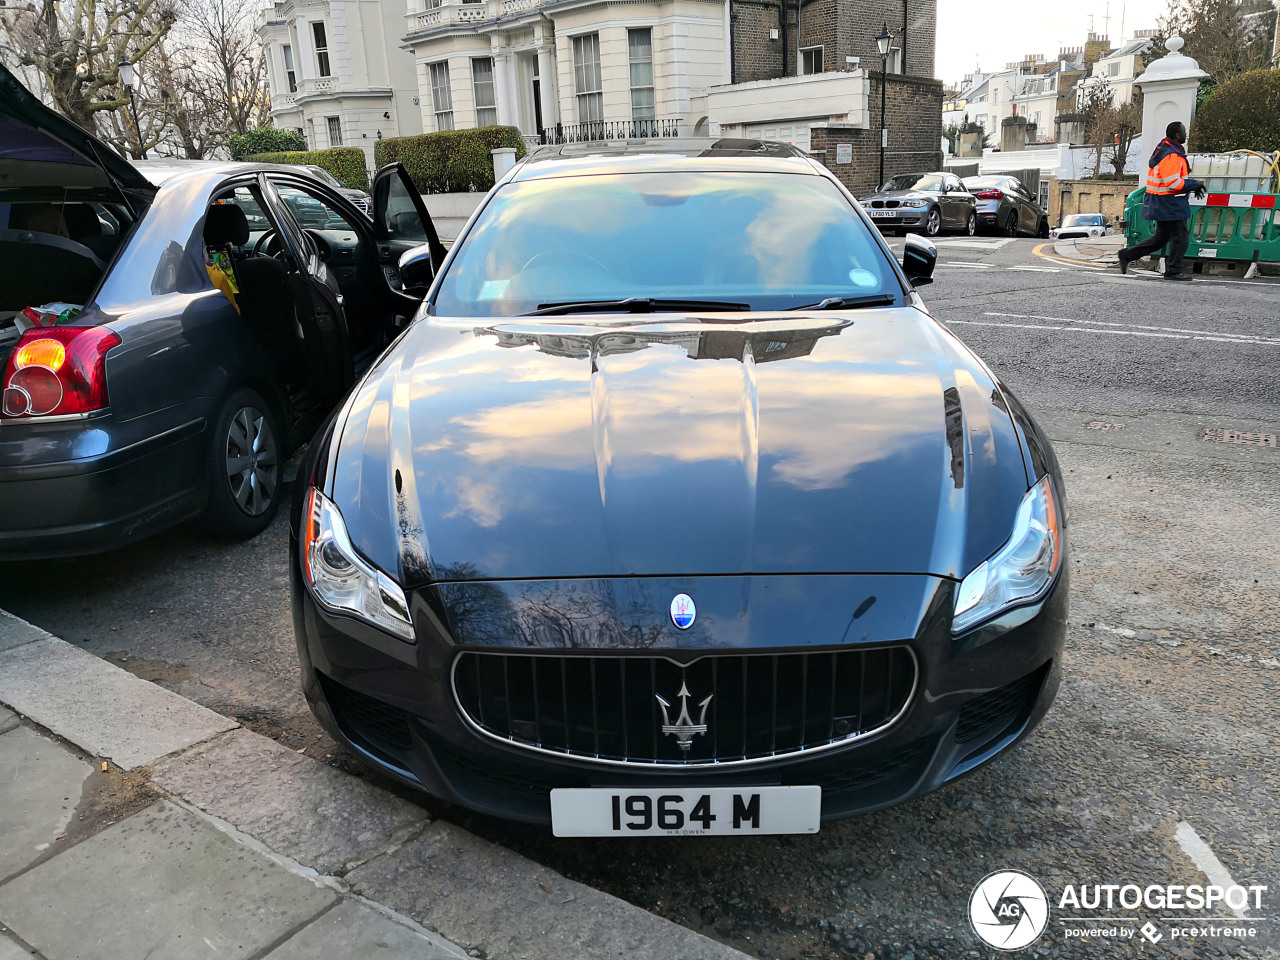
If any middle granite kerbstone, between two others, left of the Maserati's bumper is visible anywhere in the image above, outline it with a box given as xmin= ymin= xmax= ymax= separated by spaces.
xmin=151 ymin=730 xmax=429 ymax=873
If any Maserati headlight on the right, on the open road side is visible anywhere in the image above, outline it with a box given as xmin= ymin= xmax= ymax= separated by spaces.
xmin=951 ymin=476 xmax=1062 ymax=634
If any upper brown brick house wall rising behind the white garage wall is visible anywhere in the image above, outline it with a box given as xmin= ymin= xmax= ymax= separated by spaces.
xmin=731 ymin=0 xmax=938 ymax=82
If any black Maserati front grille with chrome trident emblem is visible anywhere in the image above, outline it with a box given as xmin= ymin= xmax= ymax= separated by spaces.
xmin=453 ymin=646 xmax=916 ymax=767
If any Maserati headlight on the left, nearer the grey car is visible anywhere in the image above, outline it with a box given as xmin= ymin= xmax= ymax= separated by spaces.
xmin=302 ymin=486 xmax=415 ymax=640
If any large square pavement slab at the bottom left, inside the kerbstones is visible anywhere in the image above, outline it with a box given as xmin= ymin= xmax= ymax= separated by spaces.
xmin=0 ymin=801 xmax=337 ymax=960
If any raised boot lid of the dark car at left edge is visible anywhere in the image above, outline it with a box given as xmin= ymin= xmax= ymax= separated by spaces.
xmin=0 ymin=67 xmax=156 ymax=197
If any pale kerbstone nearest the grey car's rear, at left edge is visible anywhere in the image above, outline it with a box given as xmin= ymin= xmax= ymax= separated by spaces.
xmin=0 ymin=637 xmax=236 ymax=771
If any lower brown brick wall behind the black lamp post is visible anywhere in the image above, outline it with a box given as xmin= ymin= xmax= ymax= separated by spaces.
xmin=810 ymin=73 xmax=942 ymax=196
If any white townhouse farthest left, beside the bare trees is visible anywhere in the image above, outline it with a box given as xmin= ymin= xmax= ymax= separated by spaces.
xmin=257 ymin=0 xmax=422 ymax=169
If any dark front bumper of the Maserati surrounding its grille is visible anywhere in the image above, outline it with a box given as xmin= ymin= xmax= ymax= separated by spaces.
xmin=291 ymin=563 xmax=1068 ymax=824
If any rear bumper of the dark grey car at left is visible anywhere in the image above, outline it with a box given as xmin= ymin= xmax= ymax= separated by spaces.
xmin=0 ymin=417 xmax=205 ymax=561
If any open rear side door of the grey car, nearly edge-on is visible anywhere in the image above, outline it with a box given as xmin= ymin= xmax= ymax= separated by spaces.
xmin=257 ymin=173 xmax=355 ymax=410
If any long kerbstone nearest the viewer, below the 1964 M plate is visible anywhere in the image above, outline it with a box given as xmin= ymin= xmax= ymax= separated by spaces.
xmin=347 ymin=822 xmax=745 ymax=960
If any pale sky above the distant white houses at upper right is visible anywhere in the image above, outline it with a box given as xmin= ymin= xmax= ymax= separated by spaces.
xmin=934 ymin=0 xmax=1169 ymax=84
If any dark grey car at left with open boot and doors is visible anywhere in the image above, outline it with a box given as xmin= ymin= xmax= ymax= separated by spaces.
xmin=0 ymin=68 xmax=444 ymax=559
